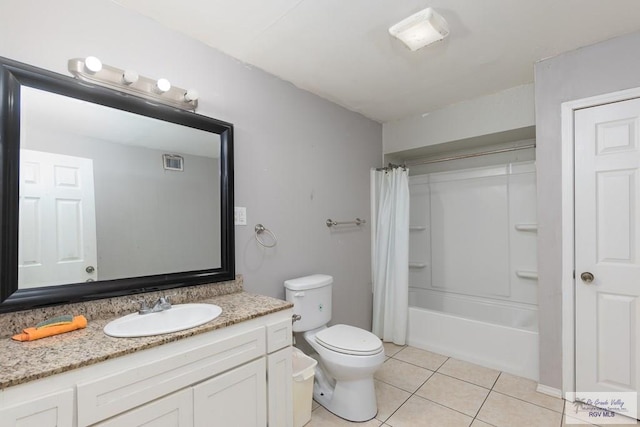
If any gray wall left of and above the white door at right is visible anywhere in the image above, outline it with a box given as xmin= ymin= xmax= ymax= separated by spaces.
xmin=535 ymin=33 xmax=640 ymax=389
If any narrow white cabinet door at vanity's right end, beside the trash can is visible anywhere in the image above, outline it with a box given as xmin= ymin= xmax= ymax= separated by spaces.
xmin=267 ymin=348 xmax=293 ymax=427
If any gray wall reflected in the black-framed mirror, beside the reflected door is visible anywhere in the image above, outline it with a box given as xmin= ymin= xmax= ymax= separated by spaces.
xmin=21 ymin=129 xmax=221 ymax=280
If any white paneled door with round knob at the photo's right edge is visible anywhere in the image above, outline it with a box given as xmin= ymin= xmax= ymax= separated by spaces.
xmin=575 ymin=99 xmax=640 ymax=414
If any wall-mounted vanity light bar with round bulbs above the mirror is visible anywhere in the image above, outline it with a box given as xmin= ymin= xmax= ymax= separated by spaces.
xmin=68 ymin=56 xmax=198 ymax=111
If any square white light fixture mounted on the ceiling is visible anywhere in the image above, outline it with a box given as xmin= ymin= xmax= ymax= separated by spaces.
xmin=389 ymin=7 xmax=449 ymax=51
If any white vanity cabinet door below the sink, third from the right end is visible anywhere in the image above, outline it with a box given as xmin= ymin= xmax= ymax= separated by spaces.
xmin=96 ymin=388 xmax=193 ymax=427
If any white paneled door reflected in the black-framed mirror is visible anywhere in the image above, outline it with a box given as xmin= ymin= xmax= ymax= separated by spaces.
xmin=18 ymin=150 xmax=98 ymax=289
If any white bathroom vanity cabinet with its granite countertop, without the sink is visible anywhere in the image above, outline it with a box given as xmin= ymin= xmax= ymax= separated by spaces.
xmin=0 ymin=292 xmax=293 ymax=427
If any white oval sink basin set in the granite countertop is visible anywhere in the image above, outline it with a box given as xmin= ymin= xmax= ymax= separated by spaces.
xmin=104 ymin=304 xmax=222 ymax=338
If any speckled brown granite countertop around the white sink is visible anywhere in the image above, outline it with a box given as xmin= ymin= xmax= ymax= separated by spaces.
xmin=0 ymin=292 xmax=293 ymax=390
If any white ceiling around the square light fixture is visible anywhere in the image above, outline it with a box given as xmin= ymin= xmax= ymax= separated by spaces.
xmin=114 ymin=0 xmax=640 ymax=122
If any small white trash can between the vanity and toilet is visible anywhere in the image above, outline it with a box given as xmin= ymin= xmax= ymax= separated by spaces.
xmin=292 ymin=347 xmax=318 ymax=427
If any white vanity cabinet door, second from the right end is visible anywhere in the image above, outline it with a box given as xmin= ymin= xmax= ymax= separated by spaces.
xmin=193 ymin=357 xmax=267 ymax=427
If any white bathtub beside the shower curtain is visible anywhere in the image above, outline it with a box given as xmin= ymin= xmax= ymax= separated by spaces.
xmin=407 ymin=288 xmax=539 ymax=381
